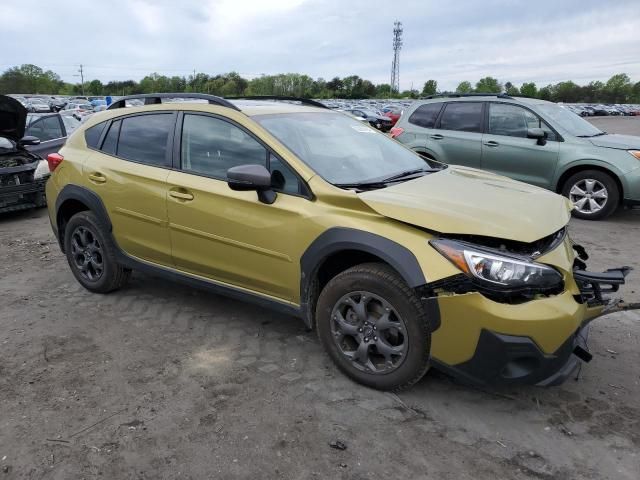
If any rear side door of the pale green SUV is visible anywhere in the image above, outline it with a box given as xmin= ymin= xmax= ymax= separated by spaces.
xmin=427 ymin=101 xmax=484 ymax=168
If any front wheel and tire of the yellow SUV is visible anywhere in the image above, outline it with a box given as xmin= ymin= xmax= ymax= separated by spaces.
xmin=316 ymin=263 xmax=431 ymax=391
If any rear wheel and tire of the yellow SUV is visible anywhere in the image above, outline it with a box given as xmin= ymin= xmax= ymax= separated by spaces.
xmin=64 ymin=211 xmax=131 ymax=293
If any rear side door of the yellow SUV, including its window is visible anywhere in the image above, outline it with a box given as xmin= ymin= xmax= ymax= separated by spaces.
xmin=83 ymin=112 xmax=176 ymax=265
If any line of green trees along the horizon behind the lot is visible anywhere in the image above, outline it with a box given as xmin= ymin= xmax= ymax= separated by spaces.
xmin=0 ymin=64 xmax=640 ymax=103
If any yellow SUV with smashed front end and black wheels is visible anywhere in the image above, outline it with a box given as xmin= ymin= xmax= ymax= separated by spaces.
xmin=46 ymin=94 xmax=629 ymax=389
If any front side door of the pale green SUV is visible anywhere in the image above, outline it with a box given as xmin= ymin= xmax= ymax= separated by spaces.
xmin=482 ymin=102 xmax=559 ymax=188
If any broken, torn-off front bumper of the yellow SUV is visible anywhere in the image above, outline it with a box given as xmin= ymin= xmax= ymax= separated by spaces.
xmin=432 ymin=241 xmax=640 ymax=386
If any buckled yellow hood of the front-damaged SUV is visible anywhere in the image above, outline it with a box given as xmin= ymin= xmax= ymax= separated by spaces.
xmin=358 ymin=166 xmax=571 ymax=243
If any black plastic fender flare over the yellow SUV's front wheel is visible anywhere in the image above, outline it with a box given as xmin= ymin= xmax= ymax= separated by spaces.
xmin=300 ymin=227 xmax=440 ymax=330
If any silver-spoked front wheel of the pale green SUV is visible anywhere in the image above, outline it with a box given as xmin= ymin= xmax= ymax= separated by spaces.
xmin=562 ymin=170 xmax=620 ymax=220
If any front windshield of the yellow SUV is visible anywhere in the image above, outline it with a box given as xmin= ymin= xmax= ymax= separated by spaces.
xmin=253 ymin=112 xmax=429 ymax=184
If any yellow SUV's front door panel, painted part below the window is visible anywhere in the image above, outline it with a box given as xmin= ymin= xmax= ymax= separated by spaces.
xmin=167 ymin=171 xmax=309 ymax=300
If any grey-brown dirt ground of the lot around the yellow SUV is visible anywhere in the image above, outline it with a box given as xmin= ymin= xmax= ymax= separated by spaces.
xmin=0 ymin=119 xmax=640 ymax=480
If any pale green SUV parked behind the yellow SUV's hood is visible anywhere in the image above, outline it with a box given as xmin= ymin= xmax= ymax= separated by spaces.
xmin=391 ymin=94 xmax=640 ymax=220
